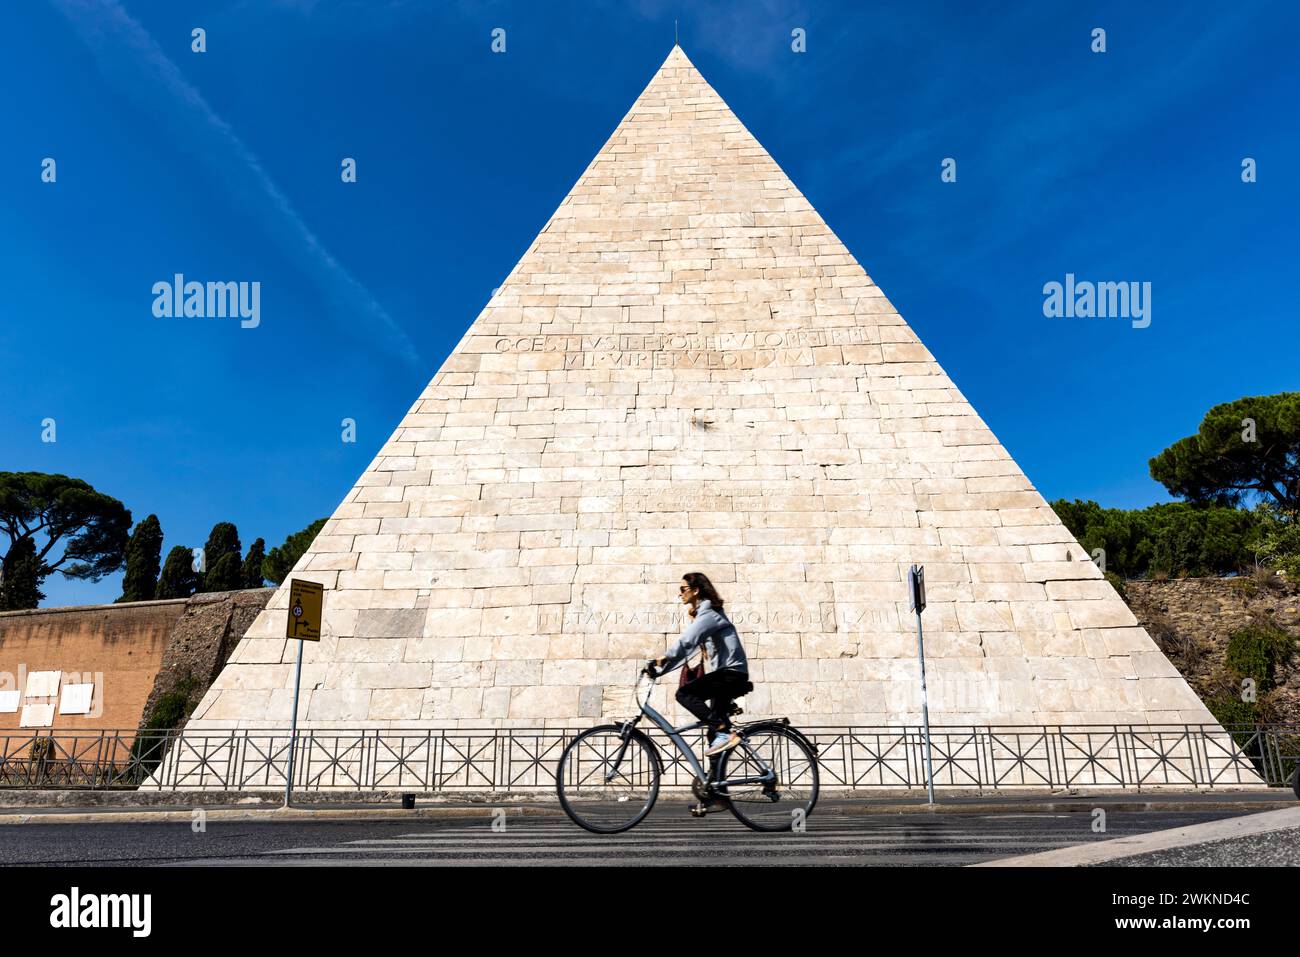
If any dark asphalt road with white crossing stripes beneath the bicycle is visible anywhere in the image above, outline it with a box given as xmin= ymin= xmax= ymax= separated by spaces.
xmin=0 ymin=802 xmax=1258 ymax=867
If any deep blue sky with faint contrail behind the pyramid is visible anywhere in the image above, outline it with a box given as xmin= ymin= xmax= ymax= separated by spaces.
xmin=0 ymin=0 xmax=1300 ymax=605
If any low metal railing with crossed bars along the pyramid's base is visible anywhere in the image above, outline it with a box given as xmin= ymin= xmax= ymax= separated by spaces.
xmin=0 ymin=724 xmax=1300 ymax=793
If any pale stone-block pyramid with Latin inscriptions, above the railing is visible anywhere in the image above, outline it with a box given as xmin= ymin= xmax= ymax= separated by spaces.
xmin=189 ymin=48 xmax=1216 ymax=731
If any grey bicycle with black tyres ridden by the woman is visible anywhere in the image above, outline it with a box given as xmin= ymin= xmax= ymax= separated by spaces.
xmin=555 ymin=662 xmax=818 ymax=833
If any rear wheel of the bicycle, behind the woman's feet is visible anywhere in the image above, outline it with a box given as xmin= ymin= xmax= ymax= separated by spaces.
xmin=718 ymin=724 xmax=818 ymax=831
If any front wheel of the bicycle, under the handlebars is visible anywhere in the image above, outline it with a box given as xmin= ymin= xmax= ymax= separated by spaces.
xmin=555 ymin=724 xmax=662 ymax=833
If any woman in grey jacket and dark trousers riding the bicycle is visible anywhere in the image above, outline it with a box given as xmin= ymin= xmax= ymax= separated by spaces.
xmin=655 ymin=572 xmax=753 ymax=757
